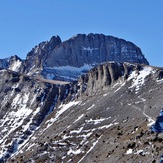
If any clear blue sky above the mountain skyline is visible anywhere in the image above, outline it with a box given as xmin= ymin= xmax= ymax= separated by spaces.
xmin=0 ymin=0 xmax=163 ymax=67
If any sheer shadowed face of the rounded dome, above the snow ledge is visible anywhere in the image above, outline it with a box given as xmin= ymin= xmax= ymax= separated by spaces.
xmin=46 ymin=34 xmax=148 ymax=67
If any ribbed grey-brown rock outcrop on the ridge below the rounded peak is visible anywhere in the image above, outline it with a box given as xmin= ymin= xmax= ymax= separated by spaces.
xmin=79 ymin=62 xmax=143 ymax=96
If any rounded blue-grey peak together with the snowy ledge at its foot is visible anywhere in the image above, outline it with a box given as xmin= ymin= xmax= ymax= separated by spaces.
xmin=41 ymin=33 xmax=149 ymax=80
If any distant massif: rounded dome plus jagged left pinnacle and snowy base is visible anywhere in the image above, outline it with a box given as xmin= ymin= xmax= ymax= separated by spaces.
xmin=19 ymin=34 xmax=148 ymax=81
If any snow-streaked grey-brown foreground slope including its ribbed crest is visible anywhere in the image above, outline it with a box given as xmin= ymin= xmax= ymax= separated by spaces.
xmin=0 ymin=62 xmax=163 ymax=163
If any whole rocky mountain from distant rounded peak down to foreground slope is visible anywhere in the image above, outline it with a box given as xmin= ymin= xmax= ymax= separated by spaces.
xmin=0 ymin=34 xmax=163 ymax=163
